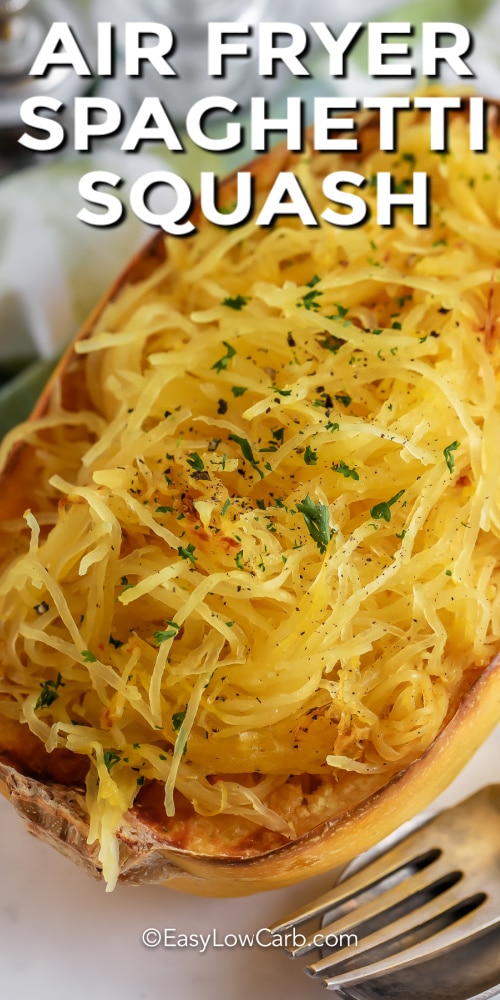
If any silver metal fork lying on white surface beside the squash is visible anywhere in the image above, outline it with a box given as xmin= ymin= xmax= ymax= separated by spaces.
xmin=270 ymin=785 xmax=500 ymax=1000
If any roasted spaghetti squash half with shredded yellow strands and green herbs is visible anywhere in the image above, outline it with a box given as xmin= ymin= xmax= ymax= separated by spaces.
xmin=0 ymin=97 xmax=500 ymax=891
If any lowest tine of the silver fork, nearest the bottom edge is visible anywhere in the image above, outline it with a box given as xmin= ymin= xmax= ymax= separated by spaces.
xmin=304 ymin=906 xmax=500 ymax=989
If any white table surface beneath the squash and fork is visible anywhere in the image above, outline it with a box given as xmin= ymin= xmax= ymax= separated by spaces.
xmin=0 ymin=728 xmax=500 ymax=1000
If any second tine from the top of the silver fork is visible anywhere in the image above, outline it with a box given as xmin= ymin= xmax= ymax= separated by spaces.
xmin=285 ymin=858 xmax=461 ymax=958
